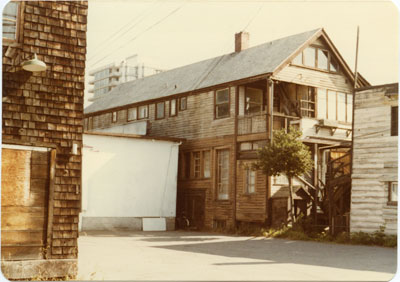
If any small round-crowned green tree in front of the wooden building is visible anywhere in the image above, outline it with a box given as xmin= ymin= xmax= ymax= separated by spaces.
xmin=253 ymin=127 xmax=313 ymax=224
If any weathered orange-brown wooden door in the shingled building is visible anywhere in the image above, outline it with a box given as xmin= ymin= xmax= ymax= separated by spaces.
xmin=1 ymin=148 xmax=49 ymax=260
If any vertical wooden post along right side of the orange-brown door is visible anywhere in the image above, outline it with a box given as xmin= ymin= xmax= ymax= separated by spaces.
xmin=46 ymin=149 xmax=57 ymax=259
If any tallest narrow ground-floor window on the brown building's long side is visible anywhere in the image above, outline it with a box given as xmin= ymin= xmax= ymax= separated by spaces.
xmin=217 ymin=150 xmax=229 ymax=200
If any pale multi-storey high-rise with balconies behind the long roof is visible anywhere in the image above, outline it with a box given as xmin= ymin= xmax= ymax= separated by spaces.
xmin=89 ymin=55 xmax=162 ymax=101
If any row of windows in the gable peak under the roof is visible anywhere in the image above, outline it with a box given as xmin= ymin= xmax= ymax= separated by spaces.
xmin=292 ymin=46 xmax=339 ymax=72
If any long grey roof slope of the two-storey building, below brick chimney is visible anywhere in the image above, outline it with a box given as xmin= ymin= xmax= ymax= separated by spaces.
xmin=85 ymin=29 xmax=322 ymax=114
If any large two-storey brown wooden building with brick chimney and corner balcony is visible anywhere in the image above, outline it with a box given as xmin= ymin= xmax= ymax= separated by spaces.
xmin=84 ymin=29 xmax=368 ymax=229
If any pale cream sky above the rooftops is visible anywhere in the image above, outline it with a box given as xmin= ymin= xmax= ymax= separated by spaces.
xmin=86 ymin=0 xmax=400 ymax=104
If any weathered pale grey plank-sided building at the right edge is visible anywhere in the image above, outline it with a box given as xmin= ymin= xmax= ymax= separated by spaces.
xmin=350 ymin=83 xmax=399 ymax=234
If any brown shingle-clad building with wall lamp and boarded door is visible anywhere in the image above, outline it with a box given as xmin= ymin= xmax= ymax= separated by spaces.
xmin=1 ymin=1 xmax=88 ymax=279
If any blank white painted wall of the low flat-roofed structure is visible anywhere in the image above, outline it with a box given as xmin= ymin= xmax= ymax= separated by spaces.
xmin=81 ymin=134 xmax=179 ymax=231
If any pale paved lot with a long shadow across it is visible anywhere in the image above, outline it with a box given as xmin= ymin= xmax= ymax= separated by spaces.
xmin=77 ymin=231 xmax=397 ymax=281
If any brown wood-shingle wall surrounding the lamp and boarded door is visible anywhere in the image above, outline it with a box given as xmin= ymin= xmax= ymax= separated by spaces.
xmin=2 ymin=1 xmax=88 ymax=258
